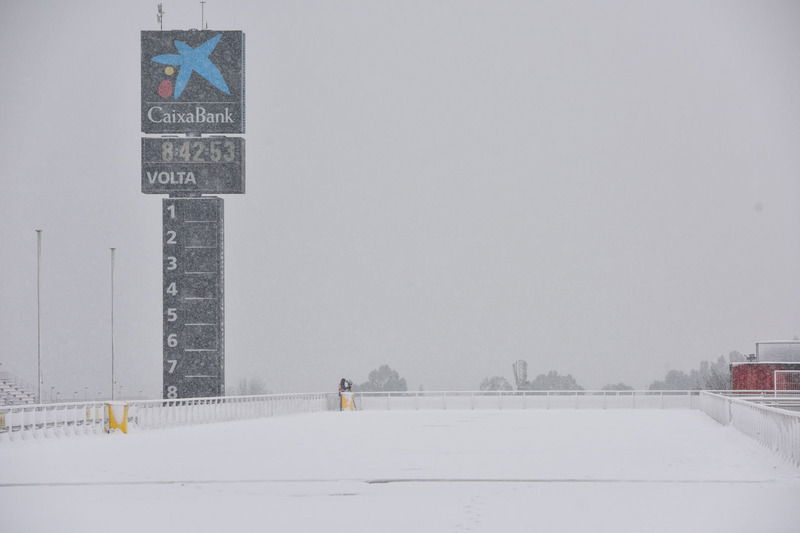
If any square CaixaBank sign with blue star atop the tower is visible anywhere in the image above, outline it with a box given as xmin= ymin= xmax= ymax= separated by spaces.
xmin=142 ymin=30 xmax=244 ymax=133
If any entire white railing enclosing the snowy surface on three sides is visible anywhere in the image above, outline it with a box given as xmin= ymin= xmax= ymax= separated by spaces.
xmin=0 ymin=391 xmax=800 ymax=466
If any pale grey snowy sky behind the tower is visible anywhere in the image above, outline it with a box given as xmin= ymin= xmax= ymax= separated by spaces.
xmin=0 ymin=0 xmax=800 ymax=397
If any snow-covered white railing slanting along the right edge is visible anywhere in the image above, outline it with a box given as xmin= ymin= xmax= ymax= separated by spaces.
xmin=700 ymin=392 xmax=800 ymax=466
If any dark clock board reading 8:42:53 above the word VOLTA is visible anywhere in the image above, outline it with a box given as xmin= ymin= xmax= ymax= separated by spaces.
xmin=142 ymin=137 xmax=244 ymax=194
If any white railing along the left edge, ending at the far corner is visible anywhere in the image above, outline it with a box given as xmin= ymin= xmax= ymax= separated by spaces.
xmin=0 ymin=393 xmax=339 ymax=441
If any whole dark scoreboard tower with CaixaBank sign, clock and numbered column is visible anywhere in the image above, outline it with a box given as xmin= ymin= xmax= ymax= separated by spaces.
xmin=141 ymin=30 xmax=245 ymax=398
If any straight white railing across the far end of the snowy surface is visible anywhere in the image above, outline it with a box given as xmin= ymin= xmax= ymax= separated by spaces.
xmin=354 ymin=390 xmax=700 ymax=411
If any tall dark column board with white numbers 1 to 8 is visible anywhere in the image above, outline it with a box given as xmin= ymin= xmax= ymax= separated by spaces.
xmin=163 ymin=197 xmax=225 ymax=398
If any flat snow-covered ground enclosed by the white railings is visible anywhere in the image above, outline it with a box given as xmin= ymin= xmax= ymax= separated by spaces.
xmin=0 ymin=410 xmax=800 ymax=533
